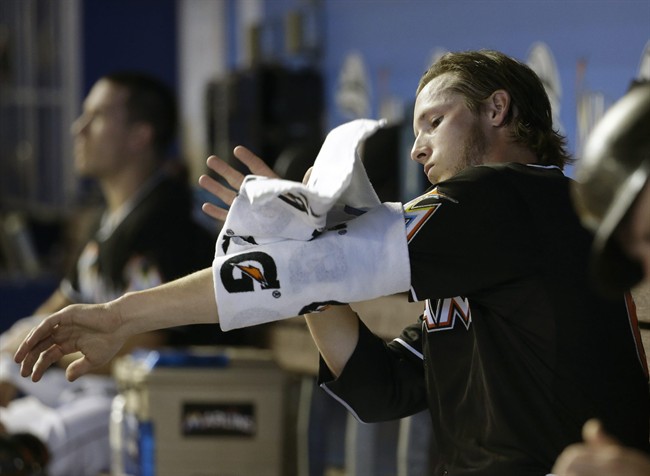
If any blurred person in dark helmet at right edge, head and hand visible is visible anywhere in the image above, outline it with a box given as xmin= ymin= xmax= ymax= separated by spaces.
xmin=553 ymin=81 xmax=650 ymax=476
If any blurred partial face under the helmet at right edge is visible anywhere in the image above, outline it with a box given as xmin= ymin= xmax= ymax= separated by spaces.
xmin=617 ymin=183 xmax=650 ymax=283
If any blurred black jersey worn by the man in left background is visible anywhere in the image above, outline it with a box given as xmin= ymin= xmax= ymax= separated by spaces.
xmin=64 ymin=175 xmax=214 ymax=303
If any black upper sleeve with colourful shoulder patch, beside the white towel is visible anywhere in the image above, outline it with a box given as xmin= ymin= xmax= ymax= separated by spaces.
xmin=404 ymin=167 xmax=531 ymax=300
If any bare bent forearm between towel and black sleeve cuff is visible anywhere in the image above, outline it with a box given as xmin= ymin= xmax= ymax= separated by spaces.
xmin=305 ymin=305 xmax=359 ymax=376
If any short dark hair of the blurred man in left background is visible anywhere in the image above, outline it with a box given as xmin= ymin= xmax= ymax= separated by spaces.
xmin=102 ymin=71 xmax=178 ymax=156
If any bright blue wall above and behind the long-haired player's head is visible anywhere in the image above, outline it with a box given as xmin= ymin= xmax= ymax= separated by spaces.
xmin=267 ymin=0 xmax=650 ymax=165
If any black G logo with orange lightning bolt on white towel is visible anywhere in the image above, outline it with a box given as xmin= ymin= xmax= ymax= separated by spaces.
xmin=220 ymin=251 xmax=280 ymax=293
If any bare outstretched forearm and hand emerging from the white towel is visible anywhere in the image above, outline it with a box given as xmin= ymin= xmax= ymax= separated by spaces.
xmin=15 ymin=268 xmax=214 ymax=382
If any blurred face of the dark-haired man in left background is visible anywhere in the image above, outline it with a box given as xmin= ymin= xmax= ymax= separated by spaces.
xmin=71 ymin=79 xmax=129 ymax=179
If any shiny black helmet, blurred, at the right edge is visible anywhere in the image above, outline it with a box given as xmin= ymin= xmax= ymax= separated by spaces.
xmin=572 ymin=81 xmax=650 ymax=293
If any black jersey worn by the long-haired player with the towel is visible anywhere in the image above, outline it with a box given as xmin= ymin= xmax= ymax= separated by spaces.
xmin=320 ymin=164 xmax=650 ymax=476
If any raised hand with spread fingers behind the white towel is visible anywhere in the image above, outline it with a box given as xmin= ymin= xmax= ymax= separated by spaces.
xmin=199 ymin=145 xmax=278 ymax=222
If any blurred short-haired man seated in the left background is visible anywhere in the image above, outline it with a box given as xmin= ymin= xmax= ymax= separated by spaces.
xmin=0 ymin=72 xmax=218 ymax=476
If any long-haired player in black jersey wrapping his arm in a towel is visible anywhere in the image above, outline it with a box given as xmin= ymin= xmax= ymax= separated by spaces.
xmin=16 ymin=51 xmax=650 ymax=476
